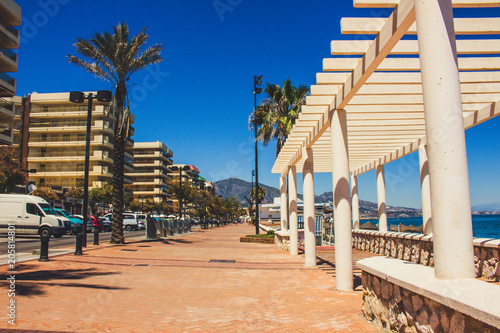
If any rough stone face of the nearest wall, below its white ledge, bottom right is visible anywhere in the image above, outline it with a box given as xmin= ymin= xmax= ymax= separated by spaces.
xmin=362 ymin=271 xmax=500 ymax=333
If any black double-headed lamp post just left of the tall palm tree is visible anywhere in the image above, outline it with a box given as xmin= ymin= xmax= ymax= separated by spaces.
xmin=69 ymin=90 xmax=112 ymax=254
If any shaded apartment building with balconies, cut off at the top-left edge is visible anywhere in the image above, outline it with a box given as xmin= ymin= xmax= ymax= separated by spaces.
xmin=0 ymin=0 xmax=21 ymax=145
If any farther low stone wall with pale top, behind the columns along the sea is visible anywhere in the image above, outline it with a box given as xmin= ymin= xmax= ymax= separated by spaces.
xmin=352 ymin=230 xmax=500 ymax=282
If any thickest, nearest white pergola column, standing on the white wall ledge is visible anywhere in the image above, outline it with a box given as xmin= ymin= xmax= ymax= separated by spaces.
xmin=415 ymin=0 xmax=475 ymax=279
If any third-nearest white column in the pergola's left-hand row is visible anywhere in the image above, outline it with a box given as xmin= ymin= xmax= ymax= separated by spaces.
xmin=302 ymin=148 xmax=316 ymax=267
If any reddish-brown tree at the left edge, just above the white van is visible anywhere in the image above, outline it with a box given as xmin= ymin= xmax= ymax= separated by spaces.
xmin=0 ymin=146 xmax=26 ymax=193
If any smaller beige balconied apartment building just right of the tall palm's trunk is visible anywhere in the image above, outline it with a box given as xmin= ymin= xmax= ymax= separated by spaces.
xmin=127 ymin=141 xmax=174 ymax=202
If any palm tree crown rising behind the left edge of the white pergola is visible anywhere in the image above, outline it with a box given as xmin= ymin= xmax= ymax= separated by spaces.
xmin=251 ymin=78 xmax=309 ymax=156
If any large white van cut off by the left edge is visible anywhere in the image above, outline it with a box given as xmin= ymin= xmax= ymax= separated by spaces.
xmin=0 ymin=194 xmax=71 ymax=238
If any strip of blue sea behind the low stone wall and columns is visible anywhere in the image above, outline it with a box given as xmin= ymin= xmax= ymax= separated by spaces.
xmin=360 ymin=215 xmax=500 ymax=239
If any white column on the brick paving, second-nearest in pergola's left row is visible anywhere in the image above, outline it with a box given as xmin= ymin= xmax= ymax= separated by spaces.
xmin=330 ymin=110 xmax=353 ymax=291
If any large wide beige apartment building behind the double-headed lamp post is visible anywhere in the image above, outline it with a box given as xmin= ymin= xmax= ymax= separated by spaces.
xmin=22 ymin=93 xmax=134 ymax=190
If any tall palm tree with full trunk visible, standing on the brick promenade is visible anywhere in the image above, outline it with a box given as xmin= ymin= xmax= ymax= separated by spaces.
xmin=68 ymin=22 xmax=163 ymax=244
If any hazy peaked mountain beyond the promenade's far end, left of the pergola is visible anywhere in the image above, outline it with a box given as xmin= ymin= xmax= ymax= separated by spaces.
xmin=214 ymin=178 xmax=280 ymax=206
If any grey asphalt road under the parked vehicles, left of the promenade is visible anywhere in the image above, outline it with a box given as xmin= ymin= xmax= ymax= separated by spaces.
xmin=0 ymin=230 xmax=145 ymax=255
